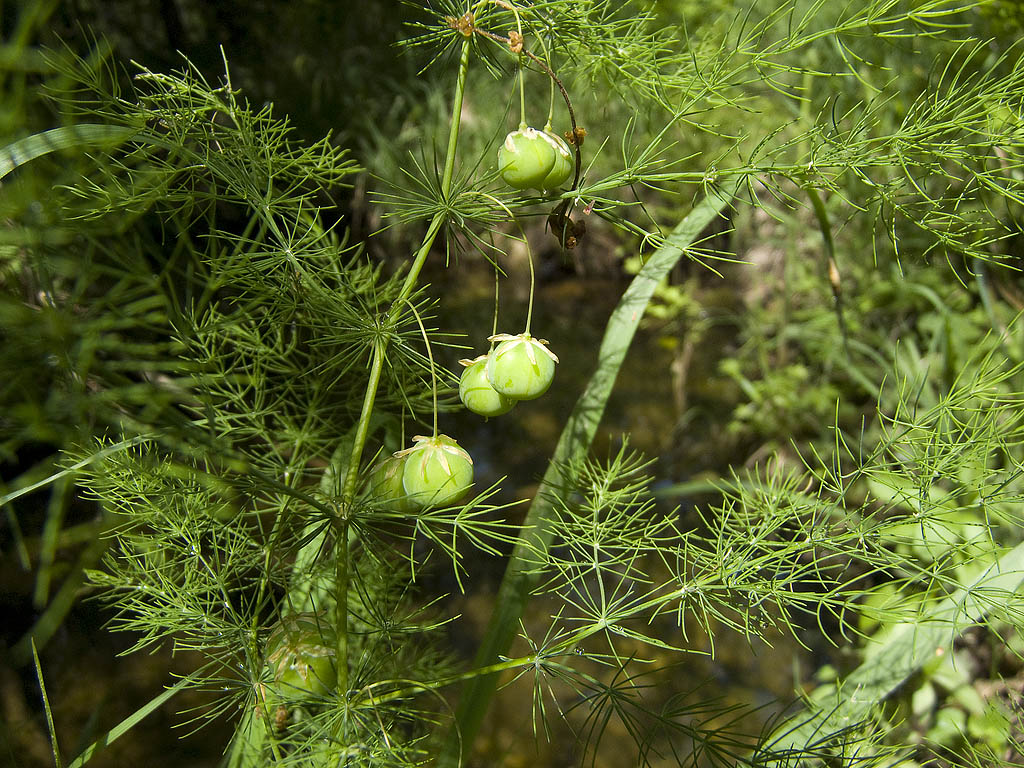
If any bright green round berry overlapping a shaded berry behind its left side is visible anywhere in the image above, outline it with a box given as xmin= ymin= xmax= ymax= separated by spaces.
xmin=400 ymin=434 xmax=473 ymax=507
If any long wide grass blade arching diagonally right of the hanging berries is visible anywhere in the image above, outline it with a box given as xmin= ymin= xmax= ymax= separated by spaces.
xmin=437 ymin=177 xmax=742 ymax=768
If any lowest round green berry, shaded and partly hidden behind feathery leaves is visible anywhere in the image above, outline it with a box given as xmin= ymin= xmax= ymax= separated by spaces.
xmin=264 ymin=613 xmax=338 ymax=706
